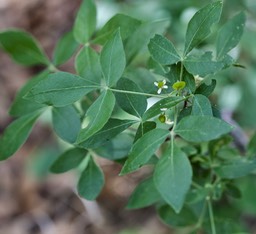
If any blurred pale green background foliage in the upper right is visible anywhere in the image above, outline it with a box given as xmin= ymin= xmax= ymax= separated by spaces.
xmin=102 ymin=0 xmax=256 ymax=126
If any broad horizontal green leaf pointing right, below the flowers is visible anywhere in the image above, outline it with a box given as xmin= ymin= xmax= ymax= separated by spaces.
xmin=175 ymin=115 xmax=233 ymax=143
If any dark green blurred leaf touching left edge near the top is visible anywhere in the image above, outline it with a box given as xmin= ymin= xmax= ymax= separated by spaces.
xmin=0 ymin=29 xmax=50 ymax=66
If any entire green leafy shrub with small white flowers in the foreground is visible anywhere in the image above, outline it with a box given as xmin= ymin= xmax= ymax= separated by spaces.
xmin=0 ymin=0 xmax=256 ymax=233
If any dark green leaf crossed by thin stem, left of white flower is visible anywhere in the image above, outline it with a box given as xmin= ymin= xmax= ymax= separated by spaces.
xmin=115 ymin=78 xmax=147 ymax=118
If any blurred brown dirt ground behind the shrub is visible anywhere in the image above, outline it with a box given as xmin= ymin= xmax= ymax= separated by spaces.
xmin=0 ymin=0 xmax=170 ymax=234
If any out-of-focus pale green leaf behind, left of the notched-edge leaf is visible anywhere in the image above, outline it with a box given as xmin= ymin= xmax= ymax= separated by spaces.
xmin=125 ymin=19 xmax=170 ymax=64
